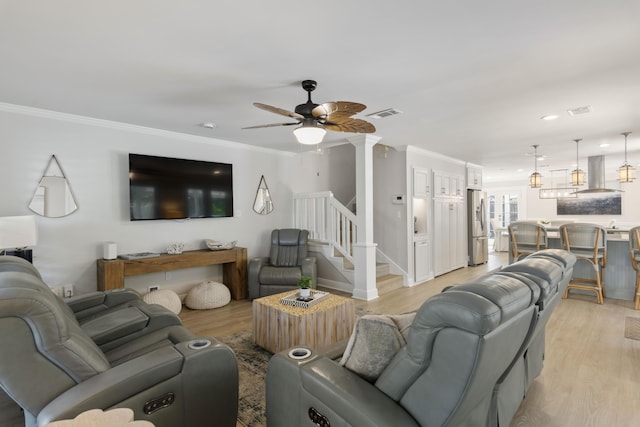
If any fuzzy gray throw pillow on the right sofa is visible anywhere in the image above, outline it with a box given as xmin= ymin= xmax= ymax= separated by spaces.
xmin=340 ymin=313 xmax=416 ymax=382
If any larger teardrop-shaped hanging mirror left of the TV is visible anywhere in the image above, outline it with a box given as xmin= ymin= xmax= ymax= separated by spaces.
xmin=29 ymin=154 xmax=78 ymax=218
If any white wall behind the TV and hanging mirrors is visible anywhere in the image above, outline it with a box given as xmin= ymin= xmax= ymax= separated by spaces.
xmin=0 ymin=104 xmax=297 ymax=293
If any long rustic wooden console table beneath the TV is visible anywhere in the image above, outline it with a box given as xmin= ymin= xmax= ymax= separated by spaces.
xmin=98 ymin=247 xmax=249 ymax=299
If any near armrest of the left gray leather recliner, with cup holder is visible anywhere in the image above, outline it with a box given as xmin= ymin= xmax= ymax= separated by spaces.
xmin=37 ymin=338 xmax=238 ymax=427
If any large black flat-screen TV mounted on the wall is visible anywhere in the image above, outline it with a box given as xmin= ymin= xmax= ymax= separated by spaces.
xmin=129 ymin=153 xmax=233 ymax=221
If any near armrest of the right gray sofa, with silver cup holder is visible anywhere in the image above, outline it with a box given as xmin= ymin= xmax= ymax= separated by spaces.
xmin=266 ymin=351 xmax=418 ymax=427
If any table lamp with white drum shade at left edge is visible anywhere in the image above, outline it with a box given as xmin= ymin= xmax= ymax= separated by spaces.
xmin=0 ymin=215 xmax=38 ymax=262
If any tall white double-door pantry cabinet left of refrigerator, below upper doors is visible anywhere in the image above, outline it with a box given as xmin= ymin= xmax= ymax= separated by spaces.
xmin=433 ymin=198 xmax=466 ymax=276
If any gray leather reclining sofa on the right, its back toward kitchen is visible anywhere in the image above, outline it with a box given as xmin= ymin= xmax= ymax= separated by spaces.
xmin=266 ymin=250 xmax=576 ymax=427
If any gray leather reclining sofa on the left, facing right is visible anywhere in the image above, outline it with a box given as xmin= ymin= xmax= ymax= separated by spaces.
xmin=0 ymin=257 xmax=238 ymax=427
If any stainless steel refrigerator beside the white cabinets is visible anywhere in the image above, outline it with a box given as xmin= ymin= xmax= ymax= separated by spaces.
xmin=467 ymin=190 xmax=489 ymax=265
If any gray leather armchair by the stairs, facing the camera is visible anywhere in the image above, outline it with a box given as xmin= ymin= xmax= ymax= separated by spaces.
xmin=248 ymin=228 xmax=317 ymax=299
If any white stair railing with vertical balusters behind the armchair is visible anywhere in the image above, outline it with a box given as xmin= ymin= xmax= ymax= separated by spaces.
xmin=293 ymin=191 xmax=357 ymax=263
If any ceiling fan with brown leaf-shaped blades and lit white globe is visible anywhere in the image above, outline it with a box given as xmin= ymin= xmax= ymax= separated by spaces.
xmin=243 ymin=80 xmax=376 ymax=144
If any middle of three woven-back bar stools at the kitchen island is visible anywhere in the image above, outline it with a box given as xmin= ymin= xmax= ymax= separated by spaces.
xmin=560 ymin=223 xmax=607 ymax=304
